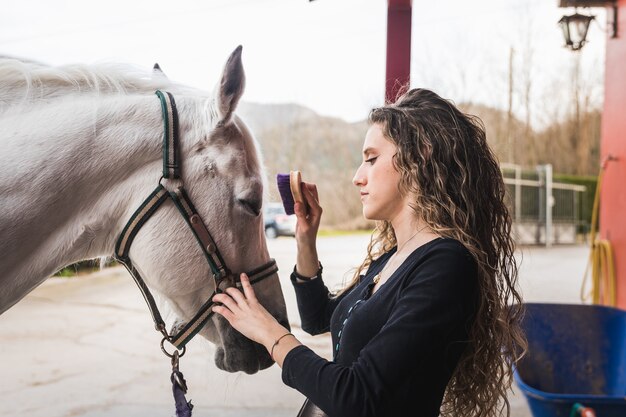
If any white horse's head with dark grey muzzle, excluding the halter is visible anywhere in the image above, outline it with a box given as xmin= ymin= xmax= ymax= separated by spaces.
xmin=118 ymin=47 xmax=289 ymax=374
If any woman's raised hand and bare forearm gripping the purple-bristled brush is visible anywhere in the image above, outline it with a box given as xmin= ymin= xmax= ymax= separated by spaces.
xmin=294 ymin=182 xmax=322 ymax=277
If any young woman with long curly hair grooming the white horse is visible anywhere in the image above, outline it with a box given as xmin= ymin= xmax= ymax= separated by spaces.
xmin=214 ymin=89 xmax=525 ymax=417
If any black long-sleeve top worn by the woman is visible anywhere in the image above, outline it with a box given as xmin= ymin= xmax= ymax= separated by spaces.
xmin=282 ymin=238 xmax=478 ymax=417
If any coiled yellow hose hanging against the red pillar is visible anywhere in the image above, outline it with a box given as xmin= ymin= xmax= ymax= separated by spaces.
xmin=580 ymin=164 xmax=617 ymax=307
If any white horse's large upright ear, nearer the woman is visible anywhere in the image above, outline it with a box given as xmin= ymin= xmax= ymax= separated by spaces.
xmin=217 ymin=45 xmax=246 ymax=124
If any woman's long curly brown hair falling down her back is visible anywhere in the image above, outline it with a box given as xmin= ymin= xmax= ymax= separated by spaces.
xmin=344 ymin=89 xmax=527 ymax=417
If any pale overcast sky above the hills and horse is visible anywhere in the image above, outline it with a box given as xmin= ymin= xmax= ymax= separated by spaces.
xmin=0 ymin=0 xmax=606 ymax=121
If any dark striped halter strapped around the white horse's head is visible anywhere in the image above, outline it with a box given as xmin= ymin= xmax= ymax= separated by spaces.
xmin=114 ymin=91 xmax=278 ymax=357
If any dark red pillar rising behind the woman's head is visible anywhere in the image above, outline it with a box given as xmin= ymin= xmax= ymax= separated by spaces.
xmin=385 ymin=0 xmax=412 ymax=103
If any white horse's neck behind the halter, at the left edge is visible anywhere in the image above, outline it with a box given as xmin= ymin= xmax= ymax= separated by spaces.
xmin=0 ymin=92 xmax=176 ymax=312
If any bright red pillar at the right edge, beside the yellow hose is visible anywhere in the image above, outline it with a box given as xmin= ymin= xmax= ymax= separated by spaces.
xmin=600 ymin=0 xmax=626 ymax=309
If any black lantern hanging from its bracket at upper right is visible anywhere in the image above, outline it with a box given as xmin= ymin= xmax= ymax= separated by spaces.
xmin=559 ymin=0 xmax=618 ymax=51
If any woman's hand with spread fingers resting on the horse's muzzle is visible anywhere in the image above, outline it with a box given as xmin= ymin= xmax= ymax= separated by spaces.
xmin=212 ymin=274 xmax=288 ymax=349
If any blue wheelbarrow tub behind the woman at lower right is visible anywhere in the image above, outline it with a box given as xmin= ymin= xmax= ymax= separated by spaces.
xmin=514 ymin=303 xmax=626 ymax=417
